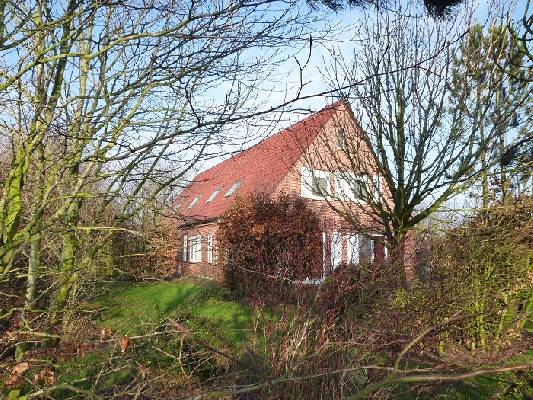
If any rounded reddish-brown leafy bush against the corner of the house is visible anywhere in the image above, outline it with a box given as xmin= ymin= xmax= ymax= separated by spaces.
xmin=218 ymin=194 xmax=322 ymax=304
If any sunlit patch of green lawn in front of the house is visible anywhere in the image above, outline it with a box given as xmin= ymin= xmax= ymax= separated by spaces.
xmin=95 ymin=280 xmax=256 ymax=346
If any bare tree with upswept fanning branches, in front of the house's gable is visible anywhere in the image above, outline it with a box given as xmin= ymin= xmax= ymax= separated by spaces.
xmin=300 ymin=2 xmax=527 ymax=282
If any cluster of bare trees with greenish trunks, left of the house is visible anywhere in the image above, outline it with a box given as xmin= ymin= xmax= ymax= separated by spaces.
xmin=0 ymin=0 xmax=320 ymax=313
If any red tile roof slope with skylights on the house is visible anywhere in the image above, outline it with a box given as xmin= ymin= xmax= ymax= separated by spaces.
xmin=176 ymin=101 xmax=340 ymax=220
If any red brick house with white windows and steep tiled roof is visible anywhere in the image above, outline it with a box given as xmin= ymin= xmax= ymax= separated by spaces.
xmin=176 ymin=101 xmax=386 ymax=282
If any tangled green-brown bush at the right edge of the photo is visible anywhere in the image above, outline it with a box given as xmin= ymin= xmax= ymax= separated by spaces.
xmin=430 ymin=198 xmax=533 ymax=350
